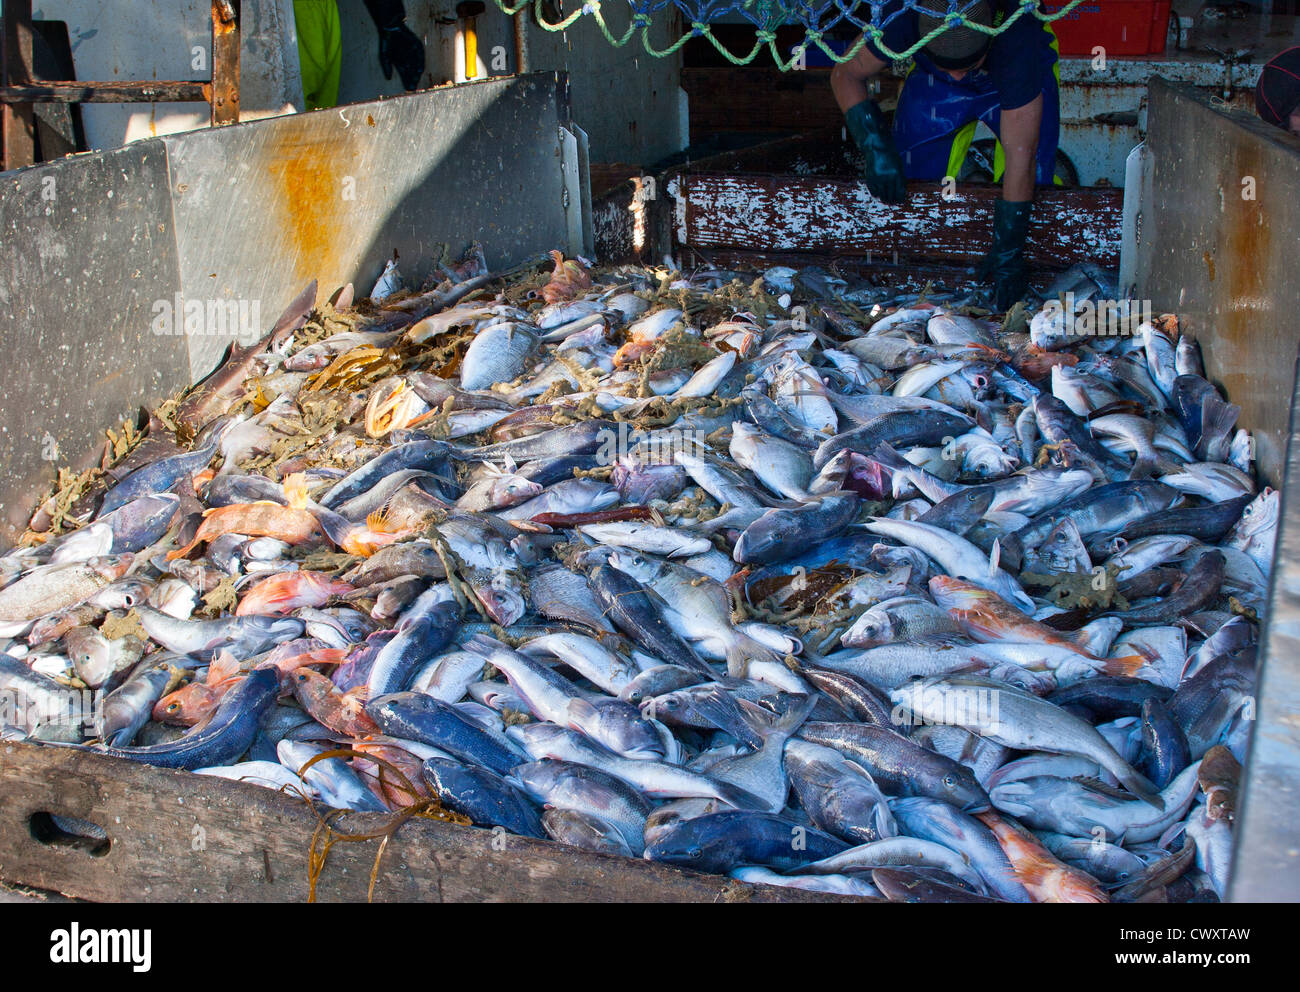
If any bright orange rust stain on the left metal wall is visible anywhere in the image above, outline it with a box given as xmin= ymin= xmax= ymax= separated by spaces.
xmin=267 ymin=129 xmax=356 ymax=295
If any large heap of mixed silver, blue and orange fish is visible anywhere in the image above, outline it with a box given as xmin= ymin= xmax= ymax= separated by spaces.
xmin=0 ymin=252 xmax=1278 ymax=902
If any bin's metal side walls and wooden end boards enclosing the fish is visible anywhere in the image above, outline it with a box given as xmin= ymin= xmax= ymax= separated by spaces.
xmin=0 ymin=73 xmax=1300 ymax=902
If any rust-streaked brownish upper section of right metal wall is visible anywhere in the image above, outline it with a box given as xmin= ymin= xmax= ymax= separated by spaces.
xmin=1138 ymin=79 xmax=1300 ymax=491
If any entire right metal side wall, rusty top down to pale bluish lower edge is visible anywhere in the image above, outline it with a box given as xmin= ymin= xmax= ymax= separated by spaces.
xmin=1138 ymin=81 xmax=1300 ymax=901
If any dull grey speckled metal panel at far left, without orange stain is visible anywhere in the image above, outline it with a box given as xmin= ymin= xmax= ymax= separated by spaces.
xmin=0 ymin=140 xmax=188 ymax=547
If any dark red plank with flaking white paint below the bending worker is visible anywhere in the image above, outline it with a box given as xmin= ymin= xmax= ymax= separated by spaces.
xmin=668 ymin=173 xmax=1123 ymax=268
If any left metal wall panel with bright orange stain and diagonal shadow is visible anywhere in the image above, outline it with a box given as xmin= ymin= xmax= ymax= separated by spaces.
xmin=163 ymin=73 xmax=577 ymax=377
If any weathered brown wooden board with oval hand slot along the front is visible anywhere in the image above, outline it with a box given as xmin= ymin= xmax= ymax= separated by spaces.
xmin=0 ymin=742 xmax=873 ymax=902
